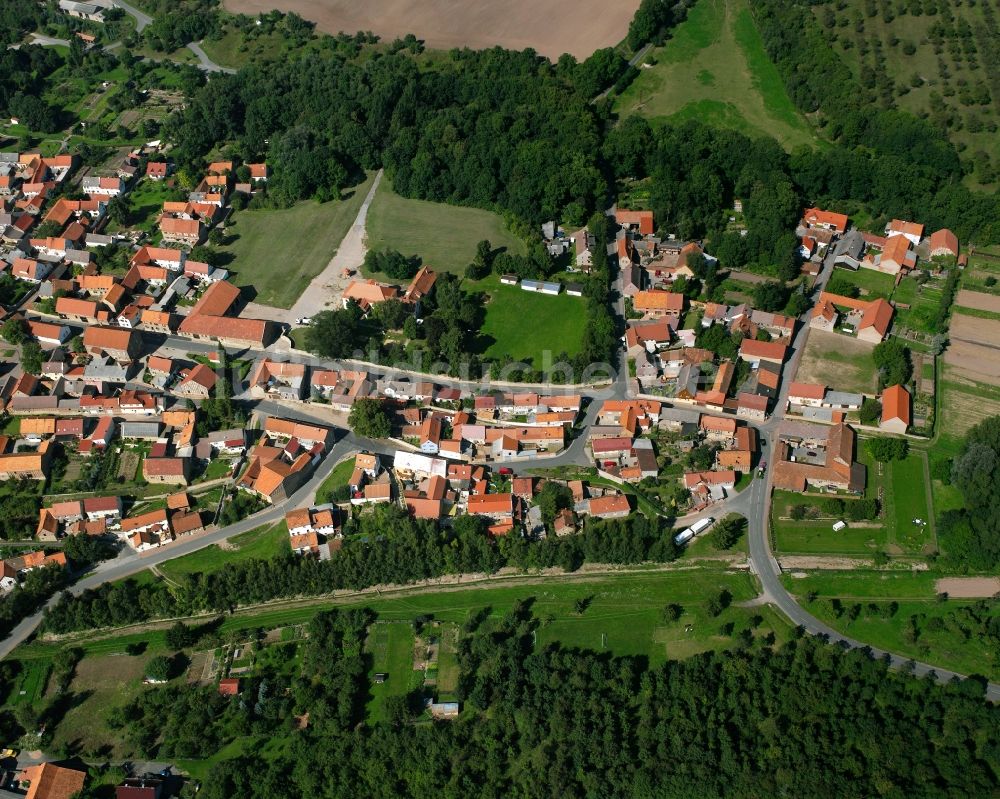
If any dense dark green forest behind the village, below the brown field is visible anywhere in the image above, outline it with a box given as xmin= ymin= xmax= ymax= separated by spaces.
xmin=152 ymin=18 xmax=1000 ymax=244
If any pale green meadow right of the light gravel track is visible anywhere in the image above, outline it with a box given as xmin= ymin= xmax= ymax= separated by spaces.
xmin=366 ymin=178 xmax=525 ymax=282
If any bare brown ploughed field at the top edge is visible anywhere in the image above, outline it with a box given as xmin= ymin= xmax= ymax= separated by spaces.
xmin=225 ymin=0 xmax=639 ymax=61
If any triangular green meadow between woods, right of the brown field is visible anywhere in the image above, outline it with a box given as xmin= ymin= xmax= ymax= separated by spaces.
xmin=615 ymin=0 xmax=817 ymax=149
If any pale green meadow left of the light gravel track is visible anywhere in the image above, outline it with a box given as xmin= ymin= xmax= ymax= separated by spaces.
xmin=220 ymin=175 xmax=374 ymax=308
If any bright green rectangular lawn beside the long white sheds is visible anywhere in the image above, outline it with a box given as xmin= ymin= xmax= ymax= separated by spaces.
xmin=462 ymin=275 xmax=586 ymax=369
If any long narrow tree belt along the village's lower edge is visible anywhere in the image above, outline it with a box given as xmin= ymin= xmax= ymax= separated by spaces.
xmin=44 ymin=505 xmax=678 ymax=633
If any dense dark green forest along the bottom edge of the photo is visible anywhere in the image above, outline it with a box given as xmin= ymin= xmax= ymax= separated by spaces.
xmin=56 ymin=602 xmax=1000 ymax=799
